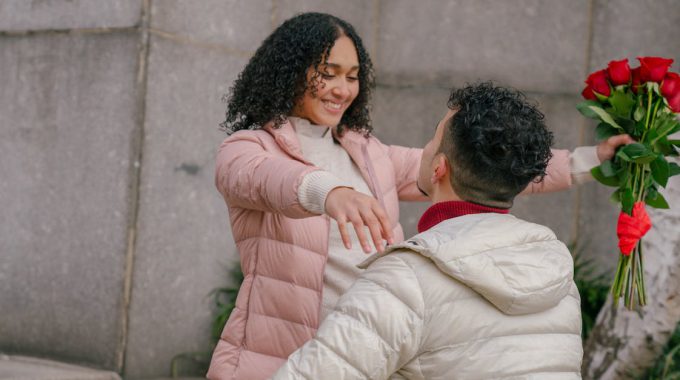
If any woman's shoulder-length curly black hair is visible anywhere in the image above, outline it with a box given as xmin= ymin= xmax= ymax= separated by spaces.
xmin=220 ymin=13 xmax=374 ymax=134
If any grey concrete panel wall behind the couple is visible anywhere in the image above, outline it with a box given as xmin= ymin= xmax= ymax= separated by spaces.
xmin=0 ymin=0 xmax=680 ymax=378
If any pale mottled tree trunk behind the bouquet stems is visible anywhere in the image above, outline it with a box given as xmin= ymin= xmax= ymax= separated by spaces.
xmin=582 ymin=171 xmax=680 ymax=380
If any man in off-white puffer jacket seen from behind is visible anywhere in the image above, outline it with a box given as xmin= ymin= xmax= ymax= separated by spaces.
xmin=274 ymin=83 xmax=583 ymax=379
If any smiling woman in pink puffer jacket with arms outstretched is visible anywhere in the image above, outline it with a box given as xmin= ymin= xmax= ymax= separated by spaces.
xmin=208 ymin=13 xmax=621 ymax=379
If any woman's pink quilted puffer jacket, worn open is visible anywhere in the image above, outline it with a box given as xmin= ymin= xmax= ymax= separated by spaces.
xmin=207 ymin=119 xmax=571 ymax=380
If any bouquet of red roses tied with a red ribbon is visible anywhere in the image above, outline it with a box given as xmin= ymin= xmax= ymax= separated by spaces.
xmin=576 ymin=57 xmax=680 ymax=309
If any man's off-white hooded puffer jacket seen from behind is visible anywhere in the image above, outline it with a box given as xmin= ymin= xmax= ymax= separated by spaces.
xmin=274 ymin=213 xmax=583 ymax=380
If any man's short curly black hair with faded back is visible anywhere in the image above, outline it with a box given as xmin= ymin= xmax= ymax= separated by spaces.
xmin=440 ymin=82 xmax=553 ymax=208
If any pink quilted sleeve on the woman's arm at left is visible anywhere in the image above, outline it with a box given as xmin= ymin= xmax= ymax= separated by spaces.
xmin=215 ymin=131 xmax=319 ymax=218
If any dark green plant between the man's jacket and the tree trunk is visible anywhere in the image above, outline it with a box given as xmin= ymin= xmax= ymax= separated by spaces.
xmin=573 ymin=252 xmax=609 ymax=342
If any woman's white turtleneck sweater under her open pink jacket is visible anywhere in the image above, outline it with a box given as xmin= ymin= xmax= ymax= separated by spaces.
xmin=290 ymin=117 xmax=373 ymax=320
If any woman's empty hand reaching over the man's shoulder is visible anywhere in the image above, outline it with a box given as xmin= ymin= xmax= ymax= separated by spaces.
xmin=326 ymin=187 xmax=394 ymax=253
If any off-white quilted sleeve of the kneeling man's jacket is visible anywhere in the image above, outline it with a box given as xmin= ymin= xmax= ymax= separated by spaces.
xmin=273 ymin=255 xmax=424 ymax=379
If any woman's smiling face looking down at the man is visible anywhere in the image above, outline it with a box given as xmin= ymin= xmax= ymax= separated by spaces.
xmin=293 ymin=35 xmax=359 ymax=127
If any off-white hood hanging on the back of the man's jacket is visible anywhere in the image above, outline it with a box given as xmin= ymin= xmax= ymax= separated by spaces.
xmin=359 ymin=213 xmax=573 ymax=315
